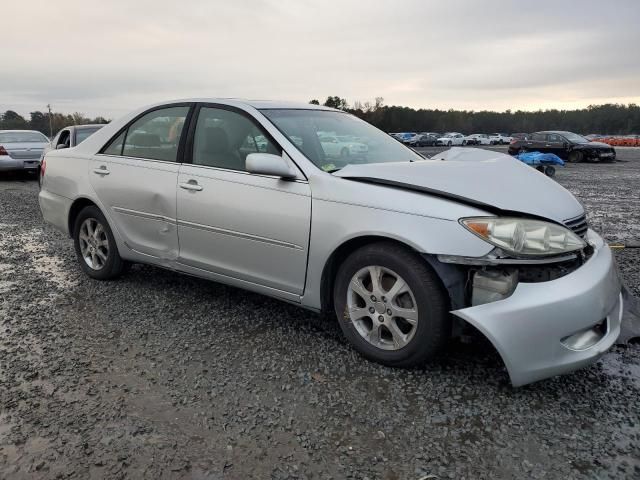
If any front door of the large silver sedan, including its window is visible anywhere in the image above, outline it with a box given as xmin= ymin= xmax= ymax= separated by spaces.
xmin=177 ymin=106 xmax=311 ymax=300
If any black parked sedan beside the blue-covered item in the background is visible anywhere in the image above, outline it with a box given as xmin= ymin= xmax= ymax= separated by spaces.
xmin=509 ymin=131 xmax=616 ymax=162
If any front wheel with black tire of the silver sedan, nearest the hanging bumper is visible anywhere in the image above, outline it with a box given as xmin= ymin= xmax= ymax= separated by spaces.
xmin=333 ymin=242 xmax=451 ymax=367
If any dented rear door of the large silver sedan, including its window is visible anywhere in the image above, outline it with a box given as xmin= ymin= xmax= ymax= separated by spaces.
xmin=89 ymin=104 xmax=191 ymax=265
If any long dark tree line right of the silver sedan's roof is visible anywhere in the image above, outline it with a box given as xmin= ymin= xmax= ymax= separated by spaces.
xmin=309 ymin=96 xmax=640 ymax=135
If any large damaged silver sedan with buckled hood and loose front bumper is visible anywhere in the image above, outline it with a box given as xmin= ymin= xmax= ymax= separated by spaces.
xmin=40 ymin=99 xmax=622 ymax=385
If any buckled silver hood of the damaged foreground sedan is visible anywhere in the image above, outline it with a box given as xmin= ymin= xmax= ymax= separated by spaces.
xmin=334 ymin=148 xmax=584 ymax=223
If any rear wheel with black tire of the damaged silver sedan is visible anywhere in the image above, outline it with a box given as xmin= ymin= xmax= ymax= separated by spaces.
xmin=73 ymin=206 xmax=126 ymax=280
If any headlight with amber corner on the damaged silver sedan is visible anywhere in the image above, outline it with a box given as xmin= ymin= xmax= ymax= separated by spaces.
xmin=460 ymin=217 xmax=586 ymax=256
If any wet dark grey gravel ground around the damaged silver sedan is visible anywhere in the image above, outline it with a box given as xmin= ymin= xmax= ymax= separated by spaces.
xmin=0 ymin=149 xmax=640 ymax=480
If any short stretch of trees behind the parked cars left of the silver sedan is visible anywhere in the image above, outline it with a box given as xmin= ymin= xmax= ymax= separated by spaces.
xmin=0 ymin=110 xmax=109 ymax=136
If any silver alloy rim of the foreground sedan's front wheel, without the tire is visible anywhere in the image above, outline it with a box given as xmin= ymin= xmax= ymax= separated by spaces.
xmin=347 ymin=266 xmax=418 ymax=350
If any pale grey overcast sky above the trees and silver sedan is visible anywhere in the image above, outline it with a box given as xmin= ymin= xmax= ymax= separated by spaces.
xmin=0 ymin=0 xmax=640 ymax=117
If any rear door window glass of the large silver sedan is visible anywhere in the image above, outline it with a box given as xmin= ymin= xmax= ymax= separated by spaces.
xmin=121 ymin=107 xmax=189 ymax=162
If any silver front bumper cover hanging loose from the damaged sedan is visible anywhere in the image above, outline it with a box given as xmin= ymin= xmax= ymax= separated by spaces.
xmin=452 ymin=230 xmax=623 ymax=386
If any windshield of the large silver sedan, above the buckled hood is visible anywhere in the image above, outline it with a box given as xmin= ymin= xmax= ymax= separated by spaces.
xmin=262 ymin=109 xmax=424 ymax=172
